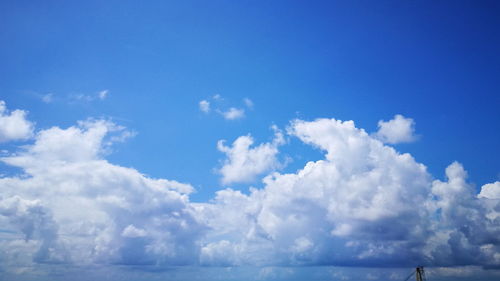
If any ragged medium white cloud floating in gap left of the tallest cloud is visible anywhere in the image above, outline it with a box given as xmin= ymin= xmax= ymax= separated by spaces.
xmin=217 ymin=127 xmax=284 ymax=184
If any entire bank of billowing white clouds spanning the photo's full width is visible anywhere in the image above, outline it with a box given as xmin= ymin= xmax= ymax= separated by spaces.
xmin=0 ymin=107 xmax=500 ymax=276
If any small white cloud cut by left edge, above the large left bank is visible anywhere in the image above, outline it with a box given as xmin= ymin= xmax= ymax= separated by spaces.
xmin=0 ymin=100 xmax=33 ymax=142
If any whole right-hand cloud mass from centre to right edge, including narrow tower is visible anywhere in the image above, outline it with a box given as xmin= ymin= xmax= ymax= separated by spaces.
xmin=198 ymin=119 xmax=500 ymax=267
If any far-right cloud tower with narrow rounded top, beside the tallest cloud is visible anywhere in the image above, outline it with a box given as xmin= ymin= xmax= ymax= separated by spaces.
xmin=424 ymin=162 xmax=500 ymax=266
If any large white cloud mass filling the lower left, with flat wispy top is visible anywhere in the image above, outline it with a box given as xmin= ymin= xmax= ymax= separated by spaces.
xmin=0 ymin=120 xmax=205 ymax=270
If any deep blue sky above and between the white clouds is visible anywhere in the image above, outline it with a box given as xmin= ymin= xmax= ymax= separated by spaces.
xmin=0 ymin=1 xmax=500 ymax=280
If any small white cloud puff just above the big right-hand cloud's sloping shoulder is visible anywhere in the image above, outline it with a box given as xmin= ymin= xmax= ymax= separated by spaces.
xmin=375 ymin=114 xmax=417 ymax=144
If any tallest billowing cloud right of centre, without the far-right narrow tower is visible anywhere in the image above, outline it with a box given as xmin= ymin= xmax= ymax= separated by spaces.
xmin=204 ymin=119 xmax=430 ymax=265
